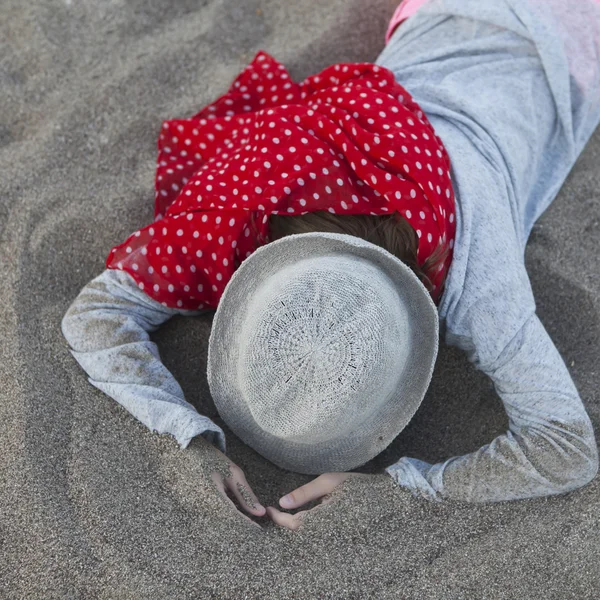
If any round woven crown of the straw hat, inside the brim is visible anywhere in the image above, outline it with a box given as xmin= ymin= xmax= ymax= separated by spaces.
xmin=239 ymin=255 xmax=411 ymax=444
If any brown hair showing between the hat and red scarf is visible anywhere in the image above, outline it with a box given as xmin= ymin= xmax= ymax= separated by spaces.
xmin=246 ymin=211 xmax=448 ymax=292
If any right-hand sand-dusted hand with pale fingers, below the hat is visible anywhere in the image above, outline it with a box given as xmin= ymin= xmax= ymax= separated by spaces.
xmin=267 ymin=473 xmax=372 ymax=530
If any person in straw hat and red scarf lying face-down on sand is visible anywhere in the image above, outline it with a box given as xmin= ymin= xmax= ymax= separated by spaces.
xmin=62 ymin=0 xmax=600 ymax=529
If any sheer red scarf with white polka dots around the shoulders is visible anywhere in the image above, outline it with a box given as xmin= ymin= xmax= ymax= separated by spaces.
xmin=106 ymin=51 xmax=456 ymax=310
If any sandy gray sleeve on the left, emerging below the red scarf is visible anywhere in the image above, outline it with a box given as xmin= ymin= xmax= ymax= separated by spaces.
xmin=61 ymin=269 xmax=226 ymax=453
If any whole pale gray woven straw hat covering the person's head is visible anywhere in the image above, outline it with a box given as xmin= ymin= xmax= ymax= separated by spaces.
xmin=207 ymin=232 xmax=439 ymax=475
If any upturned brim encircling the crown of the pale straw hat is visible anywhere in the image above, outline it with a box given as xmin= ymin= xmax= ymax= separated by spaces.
xmin=207 ymin=232 xmax=439 ymax=475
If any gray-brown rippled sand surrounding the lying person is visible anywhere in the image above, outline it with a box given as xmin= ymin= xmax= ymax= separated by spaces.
xmin=0 ymin=0 xmax=600 ymax=600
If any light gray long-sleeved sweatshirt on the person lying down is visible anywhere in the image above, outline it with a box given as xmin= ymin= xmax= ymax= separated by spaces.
xmin=62 ymin=0 xmax=600 ymax=502
